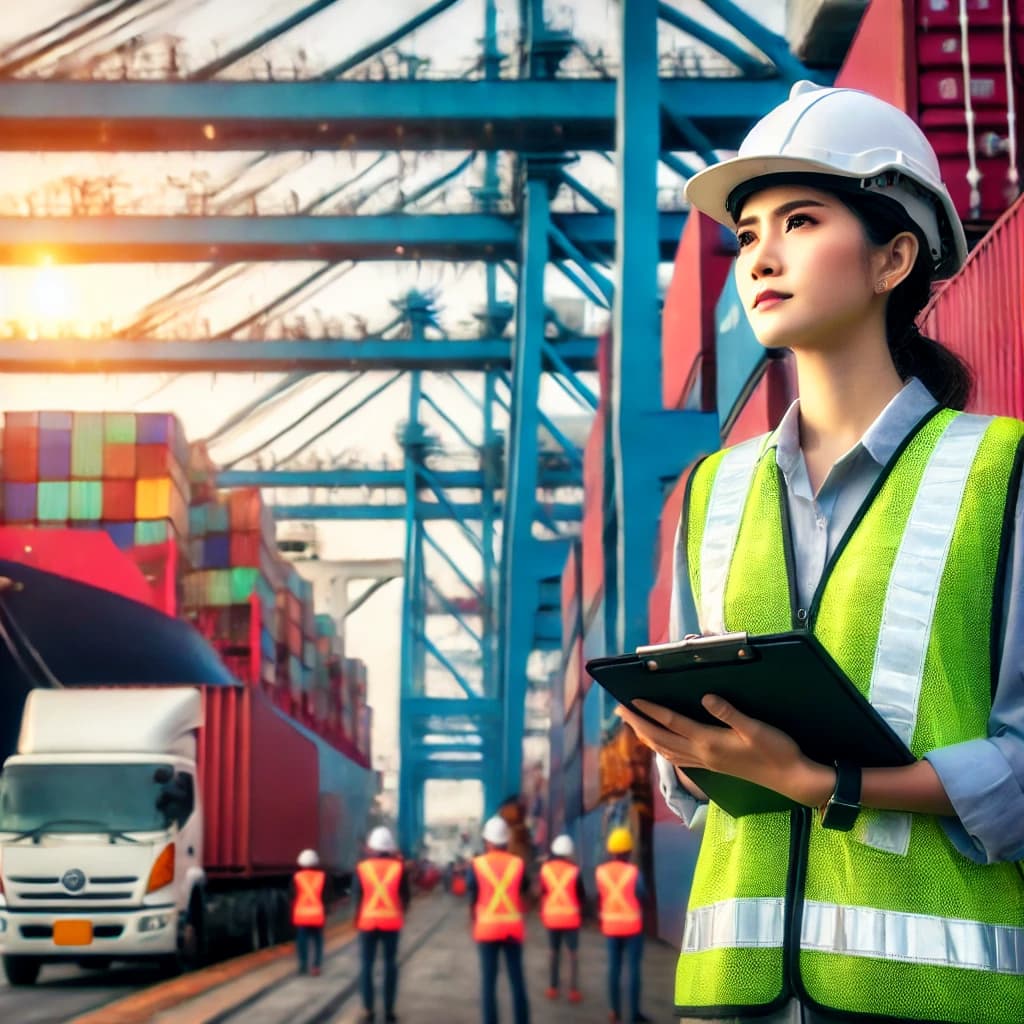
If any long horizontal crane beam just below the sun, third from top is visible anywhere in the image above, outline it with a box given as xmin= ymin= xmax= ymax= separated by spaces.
xmin=0 ymin=338 xmax=597 ymax=374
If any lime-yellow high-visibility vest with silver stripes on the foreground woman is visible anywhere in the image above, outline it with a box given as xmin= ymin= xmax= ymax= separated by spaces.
xmin=675 ymin=410 xmax=1024 ymax=1024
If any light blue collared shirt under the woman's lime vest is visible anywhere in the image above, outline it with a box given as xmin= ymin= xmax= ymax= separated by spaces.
xmin=657 ymin=379 xmax=1024 ymax=863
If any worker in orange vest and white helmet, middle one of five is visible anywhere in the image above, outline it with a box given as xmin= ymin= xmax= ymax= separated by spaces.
xmin=466 ymin=815 xmax=529 ymax=1024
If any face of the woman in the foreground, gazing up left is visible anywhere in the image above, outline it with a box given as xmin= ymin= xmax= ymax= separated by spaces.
xmin=735 ymin=185 xmax=884 ymax=350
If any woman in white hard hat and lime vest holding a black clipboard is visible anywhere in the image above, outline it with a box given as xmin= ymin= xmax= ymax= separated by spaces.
xmin=621 ymin=83 xmax=1024 ymax=1024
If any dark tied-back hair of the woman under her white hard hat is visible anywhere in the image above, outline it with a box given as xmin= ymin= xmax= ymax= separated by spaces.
xmin=726 ymin=173 xmax=974 ymax=410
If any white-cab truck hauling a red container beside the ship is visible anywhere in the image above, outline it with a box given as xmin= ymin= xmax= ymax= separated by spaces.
xmin=0 ymin=686 xmax=373 ymax=985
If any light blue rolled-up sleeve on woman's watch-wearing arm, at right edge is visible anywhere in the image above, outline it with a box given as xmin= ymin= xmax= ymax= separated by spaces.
xmin=925 ymin=473 xmax=1024 ymax=863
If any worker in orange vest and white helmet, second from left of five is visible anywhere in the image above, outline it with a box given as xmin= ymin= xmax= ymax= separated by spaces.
xmin=352 ymin=825 xmax=410 ymax=1022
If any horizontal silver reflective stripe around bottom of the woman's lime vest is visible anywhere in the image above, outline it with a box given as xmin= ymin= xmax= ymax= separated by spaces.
xmin=683 ymin=899 xmax=1024 ymax=974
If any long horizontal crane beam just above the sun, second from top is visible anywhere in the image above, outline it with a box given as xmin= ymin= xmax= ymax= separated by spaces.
xmin=0 ymin=208 xmax=686 ymax=264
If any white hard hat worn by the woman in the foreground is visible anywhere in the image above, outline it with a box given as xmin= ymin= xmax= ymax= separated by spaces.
xmin=685 ymin=82 xmax=967 ymax=276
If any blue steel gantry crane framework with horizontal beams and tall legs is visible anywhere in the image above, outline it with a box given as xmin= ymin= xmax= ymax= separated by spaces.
xmin=0 ymin=0 xmax=822 ymax=850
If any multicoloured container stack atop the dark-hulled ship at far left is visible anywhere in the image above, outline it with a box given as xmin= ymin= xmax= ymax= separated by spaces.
xmin=3 ymin=412 xmax=190 ymax=614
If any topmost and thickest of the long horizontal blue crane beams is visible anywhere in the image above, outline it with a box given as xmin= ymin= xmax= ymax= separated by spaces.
xmin=0 ymin=78 xmax=788 ymax=153
